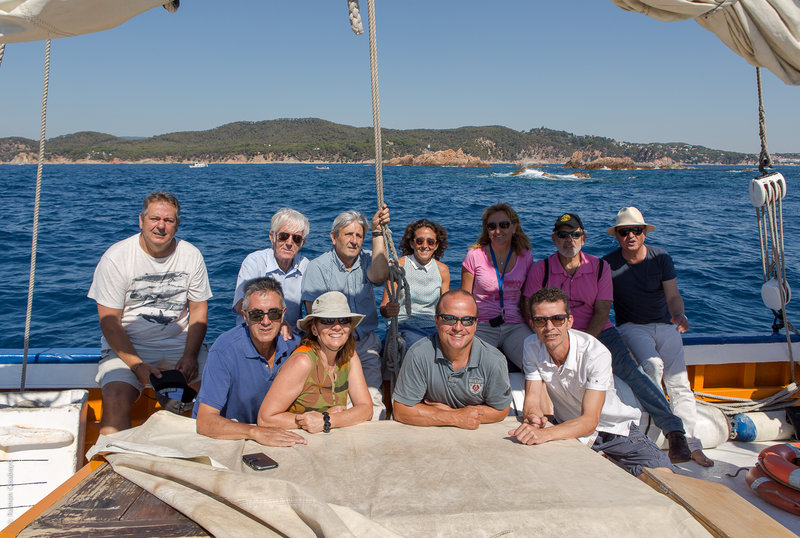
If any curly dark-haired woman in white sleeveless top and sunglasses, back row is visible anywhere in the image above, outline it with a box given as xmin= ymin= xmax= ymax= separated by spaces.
xmin=380 ymin=219 xmax=450 ymax=349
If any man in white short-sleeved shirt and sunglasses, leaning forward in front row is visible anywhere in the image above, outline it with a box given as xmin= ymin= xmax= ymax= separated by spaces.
xmin=509 ymin=288 xmax=672 ymax=476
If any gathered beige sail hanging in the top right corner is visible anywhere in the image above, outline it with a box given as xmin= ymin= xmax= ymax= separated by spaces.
xmin=611 ymin=0 xmax=800 ymax=85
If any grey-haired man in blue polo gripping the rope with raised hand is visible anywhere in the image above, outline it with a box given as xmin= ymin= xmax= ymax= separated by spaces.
xmin=301 ymin=204 xmax=389 ymax=420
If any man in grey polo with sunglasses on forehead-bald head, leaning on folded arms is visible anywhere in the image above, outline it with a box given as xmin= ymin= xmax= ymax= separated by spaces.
xmin=393 ymin=289 xmax=511 ymax=430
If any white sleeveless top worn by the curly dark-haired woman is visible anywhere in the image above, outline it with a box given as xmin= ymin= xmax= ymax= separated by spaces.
xmin=397 ymin=255 xmax=442 ymax=327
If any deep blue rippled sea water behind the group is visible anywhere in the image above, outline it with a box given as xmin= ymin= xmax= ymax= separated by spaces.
xmin=0 ymin=164 xmax=800 ymax=348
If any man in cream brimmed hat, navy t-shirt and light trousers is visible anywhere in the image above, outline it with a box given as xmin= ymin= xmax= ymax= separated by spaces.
xmin=603 ymin=207 xmax=714 ymax=467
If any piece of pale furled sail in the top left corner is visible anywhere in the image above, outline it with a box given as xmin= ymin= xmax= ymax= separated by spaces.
xmin=0 ymin=0 xmax=166 ymax=43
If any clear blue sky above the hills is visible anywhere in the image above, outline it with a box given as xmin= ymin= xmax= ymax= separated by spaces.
xmin=0 ymin=0 xmax=800 ymax=153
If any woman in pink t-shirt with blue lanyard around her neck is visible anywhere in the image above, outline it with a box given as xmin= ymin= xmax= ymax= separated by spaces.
xmin=461 ymin=204 xmax=533 ymax=369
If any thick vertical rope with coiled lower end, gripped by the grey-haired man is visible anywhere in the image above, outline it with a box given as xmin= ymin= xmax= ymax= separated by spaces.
xmin=347 ymin=0 xmax=411 ymax=383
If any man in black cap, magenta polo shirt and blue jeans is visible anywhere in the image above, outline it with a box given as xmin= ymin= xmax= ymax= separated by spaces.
xmin=524 ymin=213 xmax=691 ymax=463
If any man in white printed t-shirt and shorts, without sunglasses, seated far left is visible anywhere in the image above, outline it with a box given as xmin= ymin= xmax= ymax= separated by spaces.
xmin=88 ymin=192 xmax=211 ymax=434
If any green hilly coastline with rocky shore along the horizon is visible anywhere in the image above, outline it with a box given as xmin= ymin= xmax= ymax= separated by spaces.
xmin=0 ymin=118 xmax=800 ymax=167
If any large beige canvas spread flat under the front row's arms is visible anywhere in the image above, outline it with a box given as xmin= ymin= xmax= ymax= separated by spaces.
xmin=84 ymin=411 xmax=708 ymax=538
